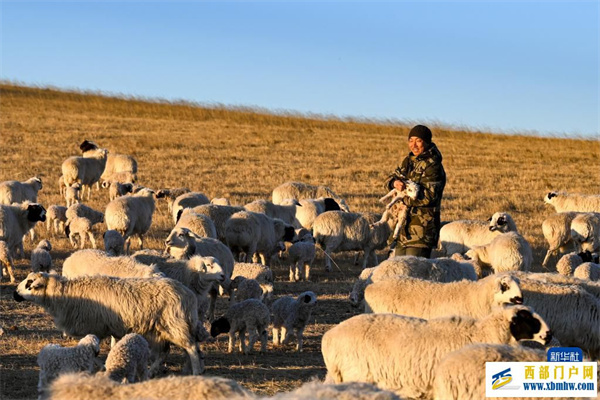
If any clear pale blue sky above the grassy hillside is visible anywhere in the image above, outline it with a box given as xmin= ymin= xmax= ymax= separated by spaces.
xmin=0 ymin=0 xmax=600 ymax=136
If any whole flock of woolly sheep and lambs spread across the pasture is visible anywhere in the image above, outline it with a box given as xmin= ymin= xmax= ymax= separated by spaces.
xmin=0 ymin=140 xmax=600 ymax=399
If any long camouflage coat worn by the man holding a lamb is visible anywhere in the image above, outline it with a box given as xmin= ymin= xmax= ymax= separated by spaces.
xmin=385 ymin=143 xmax=446 ymax=249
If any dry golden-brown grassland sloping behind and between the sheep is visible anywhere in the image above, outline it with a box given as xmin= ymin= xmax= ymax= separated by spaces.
xmin=0 ymin=83 xmax=600 ymax=399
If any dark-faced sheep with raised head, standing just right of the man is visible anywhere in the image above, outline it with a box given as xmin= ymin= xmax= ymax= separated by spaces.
xmin=438 ymin=212 xmax=517 ymax=256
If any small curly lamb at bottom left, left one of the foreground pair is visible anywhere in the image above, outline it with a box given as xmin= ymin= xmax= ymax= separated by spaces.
xmin=37 ymin=335 xmax=100 ymax=394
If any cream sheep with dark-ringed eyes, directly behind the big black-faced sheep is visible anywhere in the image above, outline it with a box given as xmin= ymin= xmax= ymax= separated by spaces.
xmin=365 ymin=275 xmax=523 ymax=319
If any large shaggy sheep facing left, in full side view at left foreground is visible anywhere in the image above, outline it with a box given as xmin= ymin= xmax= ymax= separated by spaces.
xmin=14 ymin=272 xmax=204 ymax=375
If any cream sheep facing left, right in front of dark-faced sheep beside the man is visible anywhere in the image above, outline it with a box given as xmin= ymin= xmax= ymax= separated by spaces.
xmin=466 ymin=231 xmax=533 ymax=272
